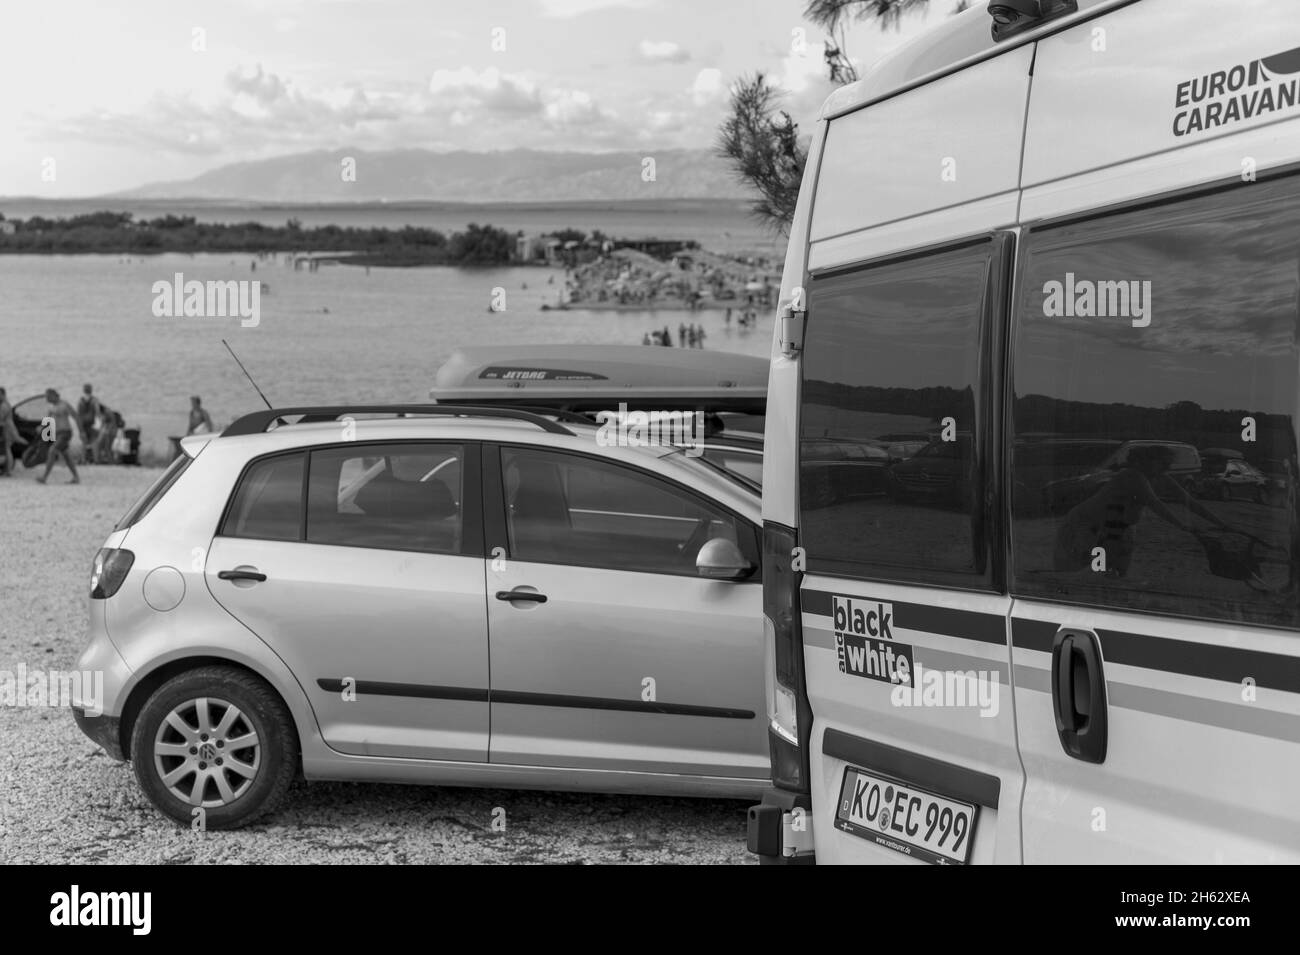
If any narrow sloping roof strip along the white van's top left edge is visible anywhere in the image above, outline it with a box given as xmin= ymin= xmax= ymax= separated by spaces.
xmin=822 ymin=0 xmax=1136 ymax=120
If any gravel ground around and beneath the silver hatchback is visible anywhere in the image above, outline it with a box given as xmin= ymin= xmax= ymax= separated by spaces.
xmin=0 ymin=466 xmax=751 ymax=864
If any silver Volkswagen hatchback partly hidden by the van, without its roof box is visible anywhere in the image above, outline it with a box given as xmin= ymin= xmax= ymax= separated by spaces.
xmin=74 ymin=405 xmax=770 ymax=829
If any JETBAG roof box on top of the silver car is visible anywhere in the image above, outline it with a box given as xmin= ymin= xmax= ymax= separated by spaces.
xmin=429 ymin=344 xmax=768 ymax=414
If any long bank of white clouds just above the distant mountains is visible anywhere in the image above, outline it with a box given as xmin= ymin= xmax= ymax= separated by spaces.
xmin=29 ymin=59 xmax=655 ymax=161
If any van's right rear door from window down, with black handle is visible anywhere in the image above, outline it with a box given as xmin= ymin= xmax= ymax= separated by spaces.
xmin=1009 ymin=175 xmax=1300 ymax=863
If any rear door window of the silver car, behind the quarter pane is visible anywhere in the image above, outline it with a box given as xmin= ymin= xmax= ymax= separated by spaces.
xmin=307 ymin=444 xmax=464 ymax=554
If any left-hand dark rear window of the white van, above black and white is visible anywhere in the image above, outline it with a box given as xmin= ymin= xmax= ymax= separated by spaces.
xmin=800 ymin=243 xmax=995 ymax=586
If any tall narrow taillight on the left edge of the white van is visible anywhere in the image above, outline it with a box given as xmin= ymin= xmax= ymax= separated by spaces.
xmin=763 ymin=524 xmax=813 ymax=793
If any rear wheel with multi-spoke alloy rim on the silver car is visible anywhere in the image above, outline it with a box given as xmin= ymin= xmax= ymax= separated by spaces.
xmin=131 ymin=667 xmax=299 ymax=829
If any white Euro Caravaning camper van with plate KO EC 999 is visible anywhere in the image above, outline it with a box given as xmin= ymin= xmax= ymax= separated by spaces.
xmin=749 ymin=0 xmax=1300 ymax=864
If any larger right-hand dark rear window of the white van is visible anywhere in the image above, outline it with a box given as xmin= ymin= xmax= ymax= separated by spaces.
xmin=1011 ymin=177 xmax=1300 ymax=628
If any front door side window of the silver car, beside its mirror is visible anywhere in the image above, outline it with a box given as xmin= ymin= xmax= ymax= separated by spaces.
xmin=502 ymin=448 xmax=758 ymax=576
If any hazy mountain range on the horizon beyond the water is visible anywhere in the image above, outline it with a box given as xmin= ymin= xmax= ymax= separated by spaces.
xmin=113 ymin=149 xmax=751 ymax=203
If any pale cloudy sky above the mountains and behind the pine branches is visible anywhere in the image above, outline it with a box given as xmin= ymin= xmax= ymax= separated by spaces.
xmin=0 ymin=0 xmax=972 ymax=197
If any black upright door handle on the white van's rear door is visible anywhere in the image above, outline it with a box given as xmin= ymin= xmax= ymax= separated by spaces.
xmin=1052 ymin=628 xmax=1108 ymax=763
